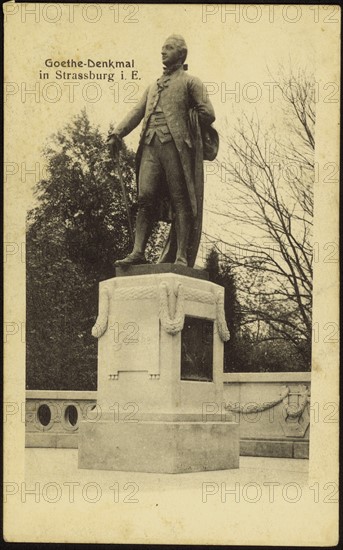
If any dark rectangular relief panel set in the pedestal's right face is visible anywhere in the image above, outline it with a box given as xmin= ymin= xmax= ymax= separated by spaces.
xmin=181 ymin=316 xmax=213 ymax=382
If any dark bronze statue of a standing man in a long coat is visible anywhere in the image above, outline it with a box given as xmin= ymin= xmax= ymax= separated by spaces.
xmin=109 ymin=35 xmax=215 ymax=267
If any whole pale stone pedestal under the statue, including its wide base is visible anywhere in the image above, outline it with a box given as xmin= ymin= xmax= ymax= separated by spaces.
xmin=79 ymin=264 xmax=239 ymax=473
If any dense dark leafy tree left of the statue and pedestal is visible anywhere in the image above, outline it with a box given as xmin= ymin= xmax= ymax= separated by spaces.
xmin=26 ymin=111 xmax=140 ymax=390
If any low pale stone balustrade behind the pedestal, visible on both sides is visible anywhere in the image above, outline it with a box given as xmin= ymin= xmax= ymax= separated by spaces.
xmin=26 ymin=372 xmax=311 ymax=458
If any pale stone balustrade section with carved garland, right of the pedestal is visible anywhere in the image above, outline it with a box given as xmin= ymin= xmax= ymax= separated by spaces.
xmin=222 ymin=372 xmax=311 ymax=458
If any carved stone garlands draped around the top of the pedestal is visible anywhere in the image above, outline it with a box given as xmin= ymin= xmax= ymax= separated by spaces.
xmin=92 ymin=282 xmax=230 ymax=342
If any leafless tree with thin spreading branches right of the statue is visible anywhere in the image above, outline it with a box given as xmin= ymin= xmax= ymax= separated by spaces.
xmin=206 ymin=70 xmax=315 ymax=362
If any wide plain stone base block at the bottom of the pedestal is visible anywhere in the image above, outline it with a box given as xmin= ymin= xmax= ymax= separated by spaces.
xmin=79 ymin=421 xmax=239 ymax=474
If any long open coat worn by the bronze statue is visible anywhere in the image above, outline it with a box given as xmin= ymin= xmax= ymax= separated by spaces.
xmin=115 ymin=67 xmax=215 ymax=266
